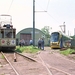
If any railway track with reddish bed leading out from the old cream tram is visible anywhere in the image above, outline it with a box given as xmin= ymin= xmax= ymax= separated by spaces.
xmin=1 ymin=52 xmax=52 ymax=75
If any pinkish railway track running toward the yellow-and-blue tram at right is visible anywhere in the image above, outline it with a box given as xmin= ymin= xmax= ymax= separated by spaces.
xmin=35 ymin=50 xmax=75 ymax=75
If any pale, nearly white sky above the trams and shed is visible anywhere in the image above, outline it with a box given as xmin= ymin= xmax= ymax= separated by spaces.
xmin=0 ymin=0 xmax=75 ymax=36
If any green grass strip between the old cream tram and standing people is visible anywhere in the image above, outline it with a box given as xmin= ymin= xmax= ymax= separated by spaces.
xmin=16 ymin=46 xmax=39 ymax=53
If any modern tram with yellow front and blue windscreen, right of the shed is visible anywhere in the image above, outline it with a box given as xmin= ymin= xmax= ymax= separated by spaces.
xmin=50 ymin=31 xmax=72 ymax=48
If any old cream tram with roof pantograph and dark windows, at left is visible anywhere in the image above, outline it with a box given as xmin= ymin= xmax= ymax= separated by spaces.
xmin=0 ymin=14 xmax=16 ymax=51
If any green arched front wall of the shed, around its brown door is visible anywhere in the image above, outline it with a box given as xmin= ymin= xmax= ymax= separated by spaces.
xmin=16 ymin=28 xmax=49 ymax=45
